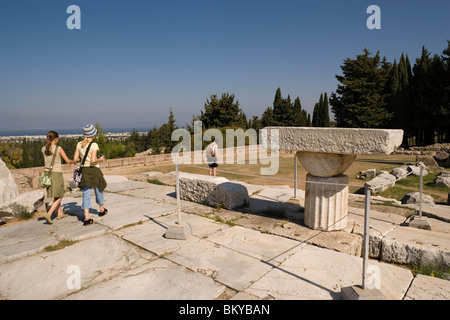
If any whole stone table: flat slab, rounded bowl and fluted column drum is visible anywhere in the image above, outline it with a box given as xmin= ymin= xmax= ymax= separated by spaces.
xmin=263 ymin=127 xmax=403 ymax=231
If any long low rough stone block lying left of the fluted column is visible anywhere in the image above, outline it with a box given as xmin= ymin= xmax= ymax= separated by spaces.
xmin=180 ymin=173 xmax=250 ymax=209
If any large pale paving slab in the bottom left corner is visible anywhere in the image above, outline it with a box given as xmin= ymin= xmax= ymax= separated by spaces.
xmin=0 ymin=235 xmax=156 ymax=300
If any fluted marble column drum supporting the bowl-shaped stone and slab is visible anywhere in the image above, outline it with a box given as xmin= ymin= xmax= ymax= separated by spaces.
xmin=305 ymin=174 xmax=348 ymax=231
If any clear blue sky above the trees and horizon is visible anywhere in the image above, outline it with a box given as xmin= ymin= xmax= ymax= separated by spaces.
xmin=0 ymin=0 xmax=450 ymax=133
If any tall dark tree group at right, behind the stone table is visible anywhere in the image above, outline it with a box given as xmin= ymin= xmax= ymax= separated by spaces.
xmin=329 ymin=40 xmax=450 ymax=147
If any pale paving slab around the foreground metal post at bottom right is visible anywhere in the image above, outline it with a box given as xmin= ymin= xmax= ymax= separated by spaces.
xmin=244 ymin=244 xmax=413 ymax=300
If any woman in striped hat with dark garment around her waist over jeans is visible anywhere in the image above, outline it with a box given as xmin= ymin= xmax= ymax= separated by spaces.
xmin=73 ymin=124 xmax=108 ymax=226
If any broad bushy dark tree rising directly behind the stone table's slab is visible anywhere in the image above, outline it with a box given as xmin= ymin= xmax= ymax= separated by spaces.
xmin=330 ymin=49 xmax=393 ymax=128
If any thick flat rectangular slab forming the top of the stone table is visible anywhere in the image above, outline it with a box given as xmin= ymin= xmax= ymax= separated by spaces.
xmin=263 ymin=127 xmax=403 ymax=154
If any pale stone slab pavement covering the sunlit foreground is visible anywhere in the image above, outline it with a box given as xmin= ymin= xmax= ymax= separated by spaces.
xmin=0 ymin=176 xmax=450 ymax=300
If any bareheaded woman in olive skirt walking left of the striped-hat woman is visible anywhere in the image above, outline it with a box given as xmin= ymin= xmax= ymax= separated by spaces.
xmin=42 ymin=131 xmax=74 ymax=224
